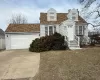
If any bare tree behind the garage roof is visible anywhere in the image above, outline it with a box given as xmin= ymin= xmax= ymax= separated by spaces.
xmin=10 ymin=14 xmax=27 ymax=24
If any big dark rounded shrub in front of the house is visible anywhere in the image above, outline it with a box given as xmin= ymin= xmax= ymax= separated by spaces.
xmin=29 ymin=33 xmax=67 ymax=52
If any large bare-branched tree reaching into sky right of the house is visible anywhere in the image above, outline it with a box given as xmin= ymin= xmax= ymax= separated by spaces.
xmin=78 ymin=0 xmax=100 ymax=27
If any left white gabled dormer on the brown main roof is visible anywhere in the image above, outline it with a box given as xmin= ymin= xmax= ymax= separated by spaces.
xmin=47 ymin=8 xmax=57 ymax=21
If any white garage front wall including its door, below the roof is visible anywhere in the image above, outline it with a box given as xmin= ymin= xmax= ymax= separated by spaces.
xmin=5 ymin=33 xmax=39 ymax=50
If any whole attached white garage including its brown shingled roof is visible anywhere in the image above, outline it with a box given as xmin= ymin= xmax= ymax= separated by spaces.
xmin=5 ymin=24 xmax=40 ymax=50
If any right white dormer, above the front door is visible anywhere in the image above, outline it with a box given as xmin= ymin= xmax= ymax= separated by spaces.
xmin=67 ymin=9 xmax=79 ymax=21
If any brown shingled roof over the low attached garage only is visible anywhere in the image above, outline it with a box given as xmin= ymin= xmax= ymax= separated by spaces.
xmin=5 ymin=24 xmax=40 ymax=32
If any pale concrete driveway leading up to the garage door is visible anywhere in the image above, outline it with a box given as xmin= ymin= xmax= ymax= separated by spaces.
xmin=0 ymin=50 xmax=40 ymax=80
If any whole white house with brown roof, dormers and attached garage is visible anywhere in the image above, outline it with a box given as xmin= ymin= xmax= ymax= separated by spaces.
xmin=5 ymin=8 xmax=88 ymax=49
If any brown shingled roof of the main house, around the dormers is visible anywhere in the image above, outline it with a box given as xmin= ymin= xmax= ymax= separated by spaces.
xmin=40 ymin=13 xmax=87 ymax=24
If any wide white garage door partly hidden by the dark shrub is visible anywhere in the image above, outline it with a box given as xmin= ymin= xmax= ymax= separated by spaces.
xmin=11 ymin=34 xmax=39 ymax=49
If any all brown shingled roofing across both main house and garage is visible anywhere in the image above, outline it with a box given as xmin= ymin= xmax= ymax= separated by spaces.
xmin=5 ymin=13 xmax=87 ymax=32
